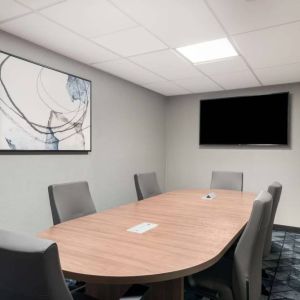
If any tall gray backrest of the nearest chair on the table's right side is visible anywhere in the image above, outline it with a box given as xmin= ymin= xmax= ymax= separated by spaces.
xmin=232 ymin=192 xmax=272 ymax=300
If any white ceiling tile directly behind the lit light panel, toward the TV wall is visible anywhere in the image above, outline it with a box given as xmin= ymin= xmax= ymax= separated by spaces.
xmin=196 ymin=56 xmax=248 ymax=76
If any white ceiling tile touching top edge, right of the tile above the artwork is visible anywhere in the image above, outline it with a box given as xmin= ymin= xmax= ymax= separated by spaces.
xmin=42 ymin=0 xmax=136 ymax=38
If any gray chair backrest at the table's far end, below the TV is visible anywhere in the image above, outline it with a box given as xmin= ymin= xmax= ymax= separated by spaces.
xmin=210 ymin=171 xmax=243 ymax=191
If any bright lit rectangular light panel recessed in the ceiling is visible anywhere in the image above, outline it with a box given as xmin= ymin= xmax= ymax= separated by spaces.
xmin=176 ymin=38 xmax=238 ymax=64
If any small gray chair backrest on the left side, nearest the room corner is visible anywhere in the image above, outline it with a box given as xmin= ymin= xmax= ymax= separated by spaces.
xmin=134 ymin=172 xmax=161 ymax=200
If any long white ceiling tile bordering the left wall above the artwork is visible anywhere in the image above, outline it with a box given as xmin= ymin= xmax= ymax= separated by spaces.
xmin=0 ymin=14 xmax=118 ymax=64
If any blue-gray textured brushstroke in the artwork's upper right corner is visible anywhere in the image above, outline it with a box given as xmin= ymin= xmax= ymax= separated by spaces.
xmin=67 ymin=75 xmax=90 ymax=104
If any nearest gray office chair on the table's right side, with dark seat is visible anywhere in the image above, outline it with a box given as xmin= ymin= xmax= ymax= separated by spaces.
xmin=189 ymin=192 xmax=272 ymax=300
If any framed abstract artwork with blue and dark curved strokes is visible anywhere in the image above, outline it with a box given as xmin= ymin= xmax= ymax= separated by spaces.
xmin=0 ymin=51 xmax=91 ymax=152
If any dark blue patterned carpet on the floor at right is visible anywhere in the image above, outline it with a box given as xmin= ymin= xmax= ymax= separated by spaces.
xmin=185 ymin=231 xmax=300 ymax=300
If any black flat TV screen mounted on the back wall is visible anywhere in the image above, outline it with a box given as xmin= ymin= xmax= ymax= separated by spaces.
xmin=200 ymin=93 xmax=289 ymax=145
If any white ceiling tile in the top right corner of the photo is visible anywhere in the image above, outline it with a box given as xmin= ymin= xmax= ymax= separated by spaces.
xmin=208 ymin=0 xmax=300 ymax=34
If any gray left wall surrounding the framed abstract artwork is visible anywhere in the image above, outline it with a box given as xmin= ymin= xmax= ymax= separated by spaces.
xmin=0 ymin=31 xmax=166 ymax=232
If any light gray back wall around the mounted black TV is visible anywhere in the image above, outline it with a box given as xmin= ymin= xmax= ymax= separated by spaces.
xmin=166 ymin=85 xmax=300 ymax=227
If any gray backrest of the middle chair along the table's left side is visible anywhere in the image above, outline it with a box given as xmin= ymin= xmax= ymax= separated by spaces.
xmin=48 ymin=181 xmax=96 ymax=225
